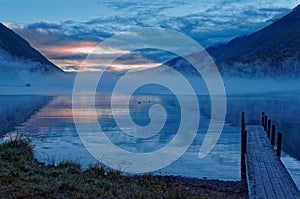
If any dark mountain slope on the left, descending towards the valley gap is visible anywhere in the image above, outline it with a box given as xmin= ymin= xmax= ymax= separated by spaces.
xmin=0 ymin=23 xmax=63 ymax=74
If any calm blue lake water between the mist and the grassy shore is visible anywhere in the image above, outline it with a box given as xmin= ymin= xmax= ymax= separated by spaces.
xmin=0 ymin=92 xmax=300 ymax=187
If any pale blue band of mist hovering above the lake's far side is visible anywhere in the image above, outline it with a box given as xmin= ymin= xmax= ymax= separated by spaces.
xmin=0 ymin=72 xmax=300 ymax=97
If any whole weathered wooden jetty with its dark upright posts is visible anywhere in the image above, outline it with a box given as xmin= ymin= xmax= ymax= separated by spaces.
xmin=241 ymin=113 xmax=300 ymax=199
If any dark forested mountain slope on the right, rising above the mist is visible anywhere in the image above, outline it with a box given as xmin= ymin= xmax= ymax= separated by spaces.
xmin=207 ymin=5 xmax=300 ymax=75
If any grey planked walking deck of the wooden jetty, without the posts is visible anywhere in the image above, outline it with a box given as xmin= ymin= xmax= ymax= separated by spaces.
xmin=245 ymin=125 xmax=300 ymax=199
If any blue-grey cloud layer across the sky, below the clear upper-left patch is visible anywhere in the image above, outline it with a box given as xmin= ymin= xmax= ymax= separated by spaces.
xmin=8 ymin=0 xmax=297 ymax=70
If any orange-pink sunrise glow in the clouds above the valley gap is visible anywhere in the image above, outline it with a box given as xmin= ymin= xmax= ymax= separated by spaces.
xmin=43 ymin=42 xmax=161 ymax=72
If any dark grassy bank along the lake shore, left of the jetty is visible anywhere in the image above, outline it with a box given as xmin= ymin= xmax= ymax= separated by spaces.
xmin=0 ymin=140 xmax=247 ymax=198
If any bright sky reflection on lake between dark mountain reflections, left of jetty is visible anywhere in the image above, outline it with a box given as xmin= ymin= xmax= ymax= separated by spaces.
xmin=5 ymin=96 xmax=240 ymax=179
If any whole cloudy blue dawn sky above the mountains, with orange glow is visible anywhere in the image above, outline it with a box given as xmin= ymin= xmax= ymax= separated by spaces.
xmin=0 ymin=0 xmax=300 ymax=71
